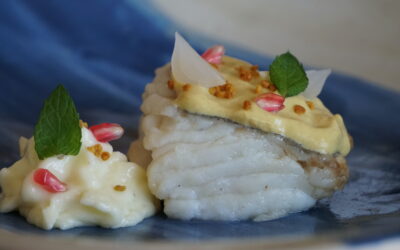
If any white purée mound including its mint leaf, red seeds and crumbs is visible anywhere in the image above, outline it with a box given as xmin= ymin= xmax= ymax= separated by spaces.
xmin=0 ymin=86 xmax=158 ymax=229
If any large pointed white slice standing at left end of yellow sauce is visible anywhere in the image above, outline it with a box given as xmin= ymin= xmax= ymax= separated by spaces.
xmin=171 ymin=32 xmax=225 ymax=88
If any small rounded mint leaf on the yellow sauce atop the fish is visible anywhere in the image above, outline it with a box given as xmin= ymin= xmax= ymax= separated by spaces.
xmin=269 ymin=51 xmax=308 ymax=97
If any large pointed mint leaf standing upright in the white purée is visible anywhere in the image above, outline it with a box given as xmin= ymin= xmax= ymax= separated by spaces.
xmin=34 ymin=85 xmax=82 ymax=160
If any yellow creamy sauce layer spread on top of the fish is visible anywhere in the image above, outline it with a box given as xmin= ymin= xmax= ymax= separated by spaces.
xmin=174 ymin=56 xmax=351 ymax=156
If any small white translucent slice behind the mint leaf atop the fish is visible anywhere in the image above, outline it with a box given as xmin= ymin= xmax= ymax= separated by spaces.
xmin=302 ymin=69 xmax=332 ymax=99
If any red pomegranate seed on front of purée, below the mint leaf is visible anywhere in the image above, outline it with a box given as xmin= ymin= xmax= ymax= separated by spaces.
xmin=33 ymin=168 xmax=67 ymax=193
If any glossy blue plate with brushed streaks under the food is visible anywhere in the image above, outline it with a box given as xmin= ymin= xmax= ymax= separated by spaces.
xmin=0 ymin=0 xmax=400 ymax=242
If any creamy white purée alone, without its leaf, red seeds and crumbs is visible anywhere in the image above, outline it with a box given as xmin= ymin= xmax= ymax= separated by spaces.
xmin=0 ymin=128 xmax=158 ymax=229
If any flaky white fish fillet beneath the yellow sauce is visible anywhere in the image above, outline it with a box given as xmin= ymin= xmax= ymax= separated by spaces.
xmin=129 ymin=65 xmax=347 ymax=220
